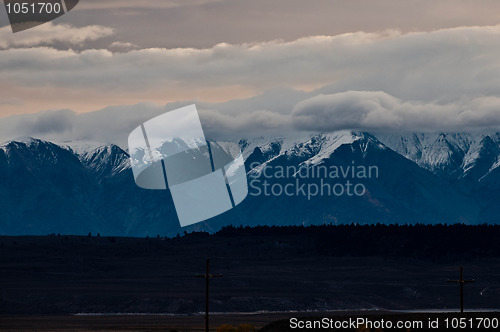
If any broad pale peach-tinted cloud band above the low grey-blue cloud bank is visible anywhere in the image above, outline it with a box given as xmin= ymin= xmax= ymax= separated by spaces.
xmin=0 ymin=26 xmax=500 ymax=114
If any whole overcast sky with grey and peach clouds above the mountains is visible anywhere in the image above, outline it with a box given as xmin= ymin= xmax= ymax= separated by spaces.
xmin=0 ymin=0 xmax=500 ymax=142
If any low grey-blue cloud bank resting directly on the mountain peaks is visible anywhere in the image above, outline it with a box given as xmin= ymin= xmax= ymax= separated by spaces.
xmin=0 ymin=89 xmax=500 ymax=147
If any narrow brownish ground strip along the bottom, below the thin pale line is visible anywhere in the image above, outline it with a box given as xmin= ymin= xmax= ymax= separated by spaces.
xmin=0 ymin=312 xmax=500 ymax=332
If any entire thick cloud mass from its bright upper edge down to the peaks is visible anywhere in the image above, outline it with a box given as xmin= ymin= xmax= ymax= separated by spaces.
xmin=0 ymin=21 xmax=500 ymax=142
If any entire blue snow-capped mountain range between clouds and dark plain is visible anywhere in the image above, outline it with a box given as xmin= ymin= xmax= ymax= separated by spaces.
xmin=0 ymin=131 xmax=500 ymax=236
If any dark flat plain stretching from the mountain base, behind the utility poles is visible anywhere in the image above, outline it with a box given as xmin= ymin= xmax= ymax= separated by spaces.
xmin=0 ymin=230 xmax=500 ymax=332
